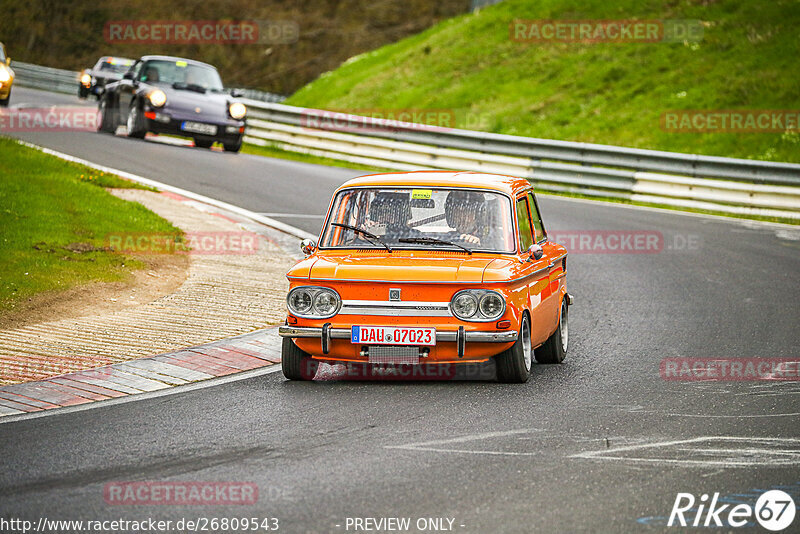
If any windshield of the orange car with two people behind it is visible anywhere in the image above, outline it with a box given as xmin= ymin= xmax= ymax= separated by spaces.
xmin=321 ymin=186 xmax=515 ymax=253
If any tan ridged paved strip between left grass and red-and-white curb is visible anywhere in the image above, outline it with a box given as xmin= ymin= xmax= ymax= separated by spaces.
xmin=0 ymin=189 xmax=299 ymax=385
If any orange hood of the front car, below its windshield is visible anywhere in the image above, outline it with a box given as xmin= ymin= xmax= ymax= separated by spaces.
xmin=287 ymin=251 xmax=494 ymax=283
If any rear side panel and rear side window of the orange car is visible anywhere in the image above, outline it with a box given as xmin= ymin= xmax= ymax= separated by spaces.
xmin=528 ymin=191 xmax=566 ymax=336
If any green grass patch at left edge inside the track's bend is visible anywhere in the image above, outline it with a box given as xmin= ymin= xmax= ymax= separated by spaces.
xmin=0 ymin=137 xmax=182 ymax=313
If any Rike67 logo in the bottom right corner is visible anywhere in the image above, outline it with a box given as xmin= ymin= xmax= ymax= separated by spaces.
xmin=667 ymin=490 xmax=797 ymax=532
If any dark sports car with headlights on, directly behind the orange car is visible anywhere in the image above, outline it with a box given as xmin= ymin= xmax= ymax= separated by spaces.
xmin=98 ymin=56 xmax=247 ymax=152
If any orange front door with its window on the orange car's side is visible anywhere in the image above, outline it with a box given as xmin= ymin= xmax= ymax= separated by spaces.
xmin=516 ymin=194 xmax=552 ymax=347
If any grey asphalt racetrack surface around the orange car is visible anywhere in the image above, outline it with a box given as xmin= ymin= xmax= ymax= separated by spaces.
xmin=0 ymin=88 xmax=800 ymax=533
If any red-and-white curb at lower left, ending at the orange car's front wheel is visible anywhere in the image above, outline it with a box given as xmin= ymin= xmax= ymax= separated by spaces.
xmin=0 ymin=327 xmax=281 ymax=422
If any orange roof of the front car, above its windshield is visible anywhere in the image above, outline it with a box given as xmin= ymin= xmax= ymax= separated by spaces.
xmin=337 ymin=171 xmax=531 ymax=196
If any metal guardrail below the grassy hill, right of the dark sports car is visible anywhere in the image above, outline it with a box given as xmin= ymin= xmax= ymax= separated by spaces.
xmin=245 ymin=102 xmax=800 ymax=219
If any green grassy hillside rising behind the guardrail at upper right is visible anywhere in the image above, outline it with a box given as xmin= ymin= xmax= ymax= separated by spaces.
xmin=286 ymin=0 xmax=800 ymax=162
